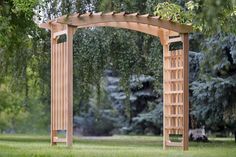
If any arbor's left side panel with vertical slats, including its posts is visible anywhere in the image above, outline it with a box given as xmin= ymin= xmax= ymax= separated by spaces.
xmin=51 ymin=26 xmax=75 ymax=146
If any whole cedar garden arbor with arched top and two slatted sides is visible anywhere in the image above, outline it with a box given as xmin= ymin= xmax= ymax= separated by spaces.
xmin=40 ymin=12 xmax=192 ymax=150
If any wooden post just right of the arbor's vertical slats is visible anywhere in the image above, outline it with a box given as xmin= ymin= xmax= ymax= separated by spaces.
xmin=66 ymin=25 xmax=74 ymax=146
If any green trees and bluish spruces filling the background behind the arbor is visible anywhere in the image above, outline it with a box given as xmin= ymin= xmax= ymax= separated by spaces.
xmin=0 ymin=0 xmax=236 ymax=135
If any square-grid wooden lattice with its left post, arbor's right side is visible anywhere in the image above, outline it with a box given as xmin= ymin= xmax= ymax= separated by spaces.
xmin=163 ymin=48 xmax=184 ymax=146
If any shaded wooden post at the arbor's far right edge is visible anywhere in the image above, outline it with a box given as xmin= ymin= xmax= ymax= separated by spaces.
xmin=182 ymin=33 xmax=189 ymax=150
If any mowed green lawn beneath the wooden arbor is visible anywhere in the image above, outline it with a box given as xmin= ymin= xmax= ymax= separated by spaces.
xmin=0 ymin=135 xmax=236 ymax=157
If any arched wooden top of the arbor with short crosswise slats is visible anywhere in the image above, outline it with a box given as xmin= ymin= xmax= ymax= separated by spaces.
xmin=40 ymin=12 xmax=192 ymax=36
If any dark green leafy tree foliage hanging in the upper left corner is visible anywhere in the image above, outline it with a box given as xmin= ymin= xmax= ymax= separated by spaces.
xmin=0 ymin=0 xmax=37 ymax=110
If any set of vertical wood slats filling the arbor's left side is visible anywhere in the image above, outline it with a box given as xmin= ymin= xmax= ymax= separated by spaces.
xmin=51 ymin=42 xmax=69 ymax=134
